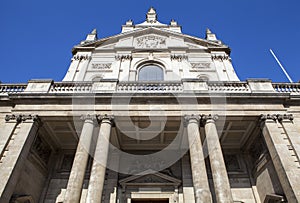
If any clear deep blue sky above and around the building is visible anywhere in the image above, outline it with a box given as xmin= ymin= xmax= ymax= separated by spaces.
xmin=0 ymin=0 xmax=300 ymax=83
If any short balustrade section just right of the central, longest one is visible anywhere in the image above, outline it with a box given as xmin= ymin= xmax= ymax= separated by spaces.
xmin=208 ymin=82 xmax=251 ymax=93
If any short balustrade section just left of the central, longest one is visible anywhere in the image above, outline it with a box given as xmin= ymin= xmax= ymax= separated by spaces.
xmin=49 ymin=82 xmax=93 ymax=93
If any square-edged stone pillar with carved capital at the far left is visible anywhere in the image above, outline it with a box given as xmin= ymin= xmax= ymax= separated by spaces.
xmin=0 ymin=115 xmax=40 ymax=202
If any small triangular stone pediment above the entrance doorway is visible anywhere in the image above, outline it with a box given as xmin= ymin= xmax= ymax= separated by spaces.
xmin=119 ymin=172 xmax=181 ymax=186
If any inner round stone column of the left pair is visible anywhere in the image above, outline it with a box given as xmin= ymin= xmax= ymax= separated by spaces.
xmin=87 ymin=115 xmax=113 ymax=203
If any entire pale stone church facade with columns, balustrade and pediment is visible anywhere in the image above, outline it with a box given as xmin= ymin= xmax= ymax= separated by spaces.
xmin=0 ymin=8 xmax=300 ymax=203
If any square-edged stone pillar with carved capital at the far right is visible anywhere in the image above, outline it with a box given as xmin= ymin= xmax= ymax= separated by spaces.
xmin=261 ymin=115 xmax=300 ymax=202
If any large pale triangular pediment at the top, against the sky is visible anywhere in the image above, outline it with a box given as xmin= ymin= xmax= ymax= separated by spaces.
xmin=74 ymin=27 xmax=229 ymax=53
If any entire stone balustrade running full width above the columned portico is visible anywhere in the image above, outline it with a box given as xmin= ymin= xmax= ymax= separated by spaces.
xmin=0 ymin=81 xmax=300 ymax=95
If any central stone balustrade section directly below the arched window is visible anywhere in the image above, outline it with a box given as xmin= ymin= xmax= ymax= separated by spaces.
xmin=117 ymin=81 xmax=183 ymax=92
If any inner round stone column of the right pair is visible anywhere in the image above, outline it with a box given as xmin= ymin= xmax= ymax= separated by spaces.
xmin=185 ymin=115 xmax=212 ymax=203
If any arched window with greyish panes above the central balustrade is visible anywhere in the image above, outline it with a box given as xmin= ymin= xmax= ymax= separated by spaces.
xmin=139 ymin=64 xmax=164 ymax=81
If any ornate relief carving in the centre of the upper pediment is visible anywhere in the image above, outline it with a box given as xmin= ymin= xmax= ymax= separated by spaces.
xmin=136 ymin=35 xmax=166 ymax=49
